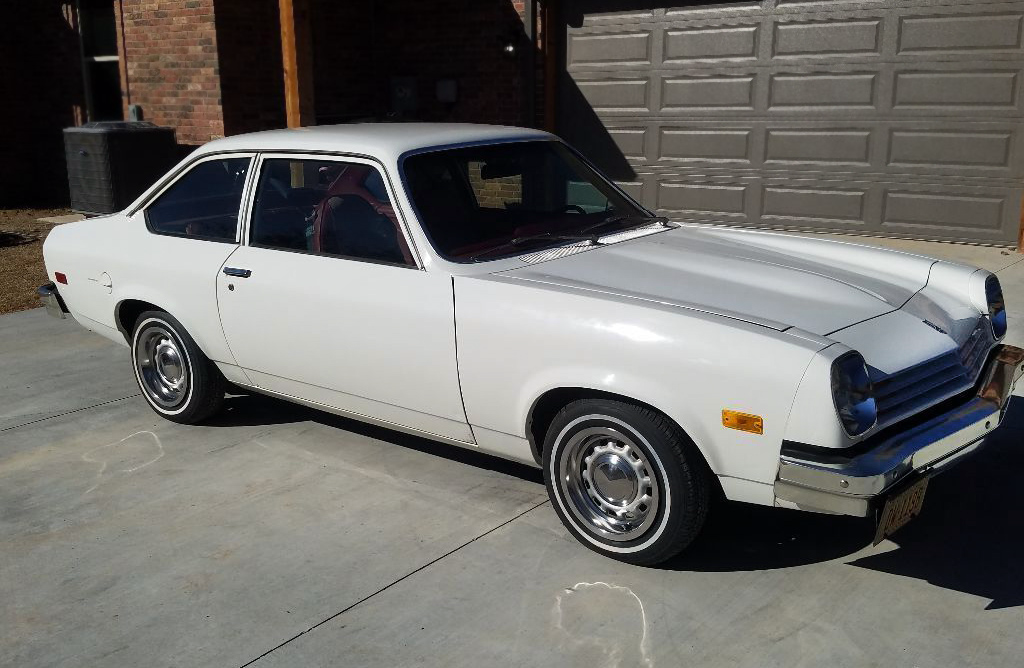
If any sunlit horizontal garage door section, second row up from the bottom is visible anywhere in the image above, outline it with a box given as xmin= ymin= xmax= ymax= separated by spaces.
xmin=606 ymin=119 xmax=1024 ymax=176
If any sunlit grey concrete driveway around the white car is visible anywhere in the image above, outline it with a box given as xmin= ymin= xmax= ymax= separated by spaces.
xmin=0 ymin=237 xmax=1024 ymax=668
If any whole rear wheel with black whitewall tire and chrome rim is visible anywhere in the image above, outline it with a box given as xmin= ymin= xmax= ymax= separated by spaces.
xmin=130 ymin=310 xmax=227 ymax=424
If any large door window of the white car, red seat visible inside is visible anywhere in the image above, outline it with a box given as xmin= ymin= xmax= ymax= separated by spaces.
xmin=249 ymin=158 xmax=415 ymax=265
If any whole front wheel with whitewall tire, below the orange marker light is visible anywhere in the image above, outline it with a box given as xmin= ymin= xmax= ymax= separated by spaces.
xmin=544 ymin=399 xmax=713 ymax=566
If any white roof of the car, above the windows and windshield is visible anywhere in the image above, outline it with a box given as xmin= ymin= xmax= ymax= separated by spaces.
xmin=196 ymin=123 xmax=553 ymax=162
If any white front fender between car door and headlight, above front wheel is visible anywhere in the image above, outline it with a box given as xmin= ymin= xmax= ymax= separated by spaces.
xmin=455 ymin=276 xmax=821 ymax=484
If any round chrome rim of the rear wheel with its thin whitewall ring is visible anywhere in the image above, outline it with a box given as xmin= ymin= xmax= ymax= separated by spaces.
xmin=135 ymin=323 xmax=188 ymax=409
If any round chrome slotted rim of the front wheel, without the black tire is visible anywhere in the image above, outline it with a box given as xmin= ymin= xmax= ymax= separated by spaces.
xmin=558 ymin=426 xmax=659 ymax=542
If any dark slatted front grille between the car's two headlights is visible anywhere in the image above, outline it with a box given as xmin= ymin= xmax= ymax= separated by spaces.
xmin=871 ymin=318 xmax=994 ymax=427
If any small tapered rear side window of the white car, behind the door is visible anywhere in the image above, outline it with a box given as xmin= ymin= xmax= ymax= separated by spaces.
xmin=145 ymin=158 xmax=252 ymax=242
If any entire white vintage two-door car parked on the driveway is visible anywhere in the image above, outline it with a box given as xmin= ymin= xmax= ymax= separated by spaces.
xmin=40 ymin=124 xmax=1024 ymax=563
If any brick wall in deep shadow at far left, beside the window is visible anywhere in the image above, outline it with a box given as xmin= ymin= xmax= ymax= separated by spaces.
xmin=0 ymin=0 xmax=85 ymax=207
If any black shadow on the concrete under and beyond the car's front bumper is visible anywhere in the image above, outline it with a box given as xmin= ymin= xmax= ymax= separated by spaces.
xmin=663 ymin=398 xmax=1024 ymax=610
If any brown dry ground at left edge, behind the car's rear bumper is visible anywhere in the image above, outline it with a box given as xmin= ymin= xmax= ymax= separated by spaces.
xmin=0 ymin=209 xmax=71 ymax=314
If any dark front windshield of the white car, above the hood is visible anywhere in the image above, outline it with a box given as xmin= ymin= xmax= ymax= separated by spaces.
xmin=402 ymin=140 xmax=651 ymax=262
